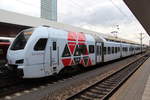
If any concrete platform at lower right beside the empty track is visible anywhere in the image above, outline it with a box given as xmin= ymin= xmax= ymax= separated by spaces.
xmin=110 ymin=58 xmax=150 ymax=100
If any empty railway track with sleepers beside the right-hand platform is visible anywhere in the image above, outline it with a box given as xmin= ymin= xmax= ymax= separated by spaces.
xmin=67 ymin=53 xmax=150 ymax=100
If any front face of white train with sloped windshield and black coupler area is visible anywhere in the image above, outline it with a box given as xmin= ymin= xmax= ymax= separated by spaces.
xmin=7 ymin=29 xmax=33 ymax=77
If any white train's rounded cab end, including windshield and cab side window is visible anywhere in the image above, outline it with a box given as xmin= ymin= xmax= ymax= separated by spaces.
xmin=7 ymin=26 xmax=48 ymax=78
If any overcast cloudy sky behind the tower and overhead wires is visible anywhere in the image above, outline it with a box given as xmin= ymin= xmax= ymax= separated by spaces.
xmin=0 ymin=0 xmax=149 ymax=44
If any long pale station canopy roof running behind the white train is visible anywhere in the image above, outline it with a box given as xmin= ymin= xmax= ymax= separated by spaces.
xmin=0 ymin=10 xmax=138 ymax=43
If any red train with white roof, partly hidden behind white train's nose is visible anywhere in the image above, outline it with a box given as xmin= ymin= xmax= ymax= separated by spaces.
xmin=0 ymin=37 xmax=14 ymax=64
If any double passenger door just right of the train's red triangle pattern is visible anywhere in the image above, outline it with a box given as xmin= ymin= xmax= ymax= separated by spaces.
xmin=96 ymin=43 xmax=102 ymax=63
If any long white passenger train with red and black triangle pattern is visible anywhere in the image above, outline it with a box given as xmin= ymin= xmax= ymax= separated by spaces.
xmin=7 ymin=26 xmax=145 ymax=78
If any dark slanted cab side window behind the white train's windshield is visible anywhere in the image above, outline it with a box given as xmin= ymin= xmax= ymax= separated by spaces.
xmin=34 ymin=38 xmax=47 ymax=51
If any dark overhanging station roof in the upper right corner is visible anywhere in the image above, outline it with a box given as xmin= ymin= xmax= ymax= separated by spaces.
xmin=124 ymin=0 xmax=150 ymax=35
